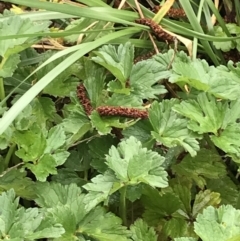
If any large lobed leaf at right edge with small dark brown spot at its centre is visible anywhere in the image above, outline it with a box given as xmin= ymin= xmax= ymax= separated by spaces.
xmin=173 ymin=93 xmax=240 ymax=162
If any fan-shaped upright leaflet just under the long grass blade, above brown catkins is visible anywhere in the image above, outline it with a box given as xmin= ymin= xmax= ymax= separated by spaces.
xmin=92 ymin=42 xmax=134 ymax=86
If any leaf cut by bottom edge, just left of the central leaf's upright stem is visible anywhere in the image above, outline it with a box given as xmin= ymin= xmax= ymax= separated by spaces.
xmin=77 ymin=207 xmax=130 ymax=241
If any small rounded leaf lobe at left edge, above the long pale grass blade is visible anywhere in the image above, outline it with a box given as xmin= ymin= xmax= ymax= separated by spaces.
xmin=0 ymin=53 xmax=20 ymax=78
